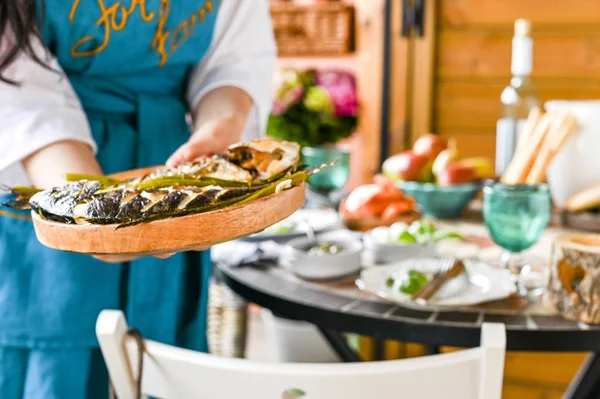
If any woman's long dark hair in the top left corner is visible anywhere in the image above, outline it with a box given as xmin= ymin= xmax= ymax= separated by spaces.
xmin=0 ymin=0 xmax=47 ymax=85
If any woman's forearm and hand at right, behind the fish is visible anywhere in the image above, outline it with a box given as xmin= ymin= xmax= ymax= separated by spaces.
xmin=167 ymin=86 xmax=252 ymax=166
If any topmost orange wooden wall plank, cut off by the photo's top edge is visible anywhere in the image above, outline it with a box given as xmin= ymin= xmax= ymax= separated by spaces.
xmin=439 ymin=0 xmax=600 ymax=28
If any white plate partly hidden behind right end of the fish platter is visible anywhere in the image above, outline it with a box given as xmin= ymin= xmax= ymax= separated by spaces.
xmin=243 ymin=209 xmax=341 ymax=241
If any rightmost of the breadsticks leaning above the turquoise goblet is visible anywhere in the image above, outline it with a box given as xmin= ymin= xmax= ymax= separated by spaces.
xmin=525 ymin=113 xmax=578 ymax=184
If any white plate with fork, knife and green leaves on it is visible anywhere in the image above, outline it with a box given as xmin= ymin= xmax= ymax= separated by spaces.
xmin=356 ymin=258 xmax=516 ymax=309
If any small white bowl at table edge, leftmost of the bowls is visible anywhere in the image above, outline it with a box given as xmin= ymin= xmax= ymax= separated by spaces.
xmin=281 ymin=238 xmax=362 ymax=280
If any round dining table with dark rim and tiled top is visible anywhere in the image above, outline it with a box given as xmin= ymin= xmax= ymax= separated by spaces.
xmin=211 ymin=209 xmax=600 ymax=399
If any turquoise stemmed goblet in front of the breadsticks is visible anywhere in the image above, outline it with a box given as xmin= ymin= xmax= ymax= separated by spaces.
xmin=483 ymin=183 xmax=552 ymax=295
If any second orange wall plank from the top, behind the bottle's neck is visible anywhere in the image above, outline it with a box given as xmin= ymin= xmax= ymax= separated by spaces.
xmin=438 ymin=30 xmax=600 ymax=79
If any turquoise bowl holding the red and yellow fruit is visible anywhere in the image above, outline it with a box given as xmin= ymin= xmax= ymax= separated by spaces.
xmin=397 ymin=181 xmax=481 ymax=219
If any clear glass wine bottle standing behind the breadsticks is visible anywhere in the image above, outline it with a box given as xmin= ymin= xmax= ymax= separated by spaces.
xmin=496 ymin=19 xmax=540 ymax=176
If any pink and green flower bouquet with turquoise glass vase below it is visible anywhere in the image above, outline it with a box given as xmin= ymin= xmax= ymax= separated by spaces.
xmin=267 ymin=69 xmax=358 ymax=195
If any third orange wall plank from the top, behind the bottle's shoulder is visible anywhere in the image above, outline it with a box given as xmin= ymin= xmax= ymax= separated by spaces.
xmin=434 ymin=80 xmax=600 ymax=134
